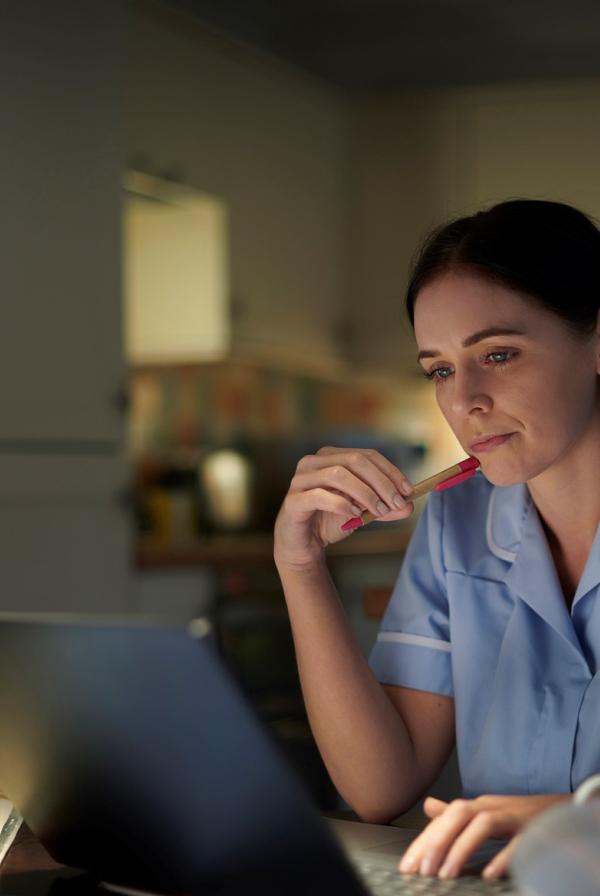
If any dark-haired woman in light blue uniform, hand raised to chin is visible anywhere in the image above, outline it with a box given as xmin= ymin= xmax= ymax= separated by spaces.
xmin=275 ymin=200 xmax=600 ymax=878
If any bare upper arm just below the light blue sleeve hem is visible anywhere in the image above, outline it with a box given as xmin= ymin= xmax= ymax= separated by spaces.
xmin=383 ymin=685 xmax=455 ymax=793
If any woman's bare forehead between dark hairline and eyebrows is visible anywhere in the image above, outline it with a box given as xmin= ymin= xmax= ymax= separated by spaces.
xmin=414 ymin=271 xmax=558 ymax=348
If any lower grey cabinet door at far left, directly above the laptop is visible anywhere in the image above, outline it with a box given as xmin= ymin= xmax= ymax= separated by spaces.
xmin=0 ymin=454 xmax=133 ymax=613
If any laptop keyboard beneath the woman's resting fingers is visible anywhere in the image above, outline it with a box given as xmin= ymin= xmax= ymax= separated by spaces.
xmin=353 ymin=859 xmax=517 ymax=896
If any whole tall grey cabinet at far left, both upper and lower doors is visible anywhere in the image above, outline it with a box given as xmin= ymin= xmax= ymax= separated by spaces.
xmin=0 ymin=0 xmax=130 ymax=612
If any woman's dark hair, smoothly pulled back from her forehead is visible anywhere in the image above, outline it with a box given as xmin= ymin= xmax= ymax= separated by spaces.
xmin=406 ymin=199 xmax=600 ymax=335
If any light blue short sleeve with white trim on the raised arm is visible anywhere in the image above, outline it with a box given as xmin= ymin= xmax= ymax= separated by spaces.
xmin=369 ymin=493 xmax=453 ymax=696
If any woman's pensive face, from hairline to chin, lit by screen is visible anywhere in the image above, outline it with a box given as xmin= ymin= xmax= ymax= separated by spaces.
xmin=415 ymin=271 xmax=598 ymax=485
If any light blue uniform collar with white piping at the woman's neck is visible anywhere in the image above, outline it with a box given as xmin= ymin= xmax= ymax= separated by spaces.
xmin=486 ymin=484 xmax=588 ymax=656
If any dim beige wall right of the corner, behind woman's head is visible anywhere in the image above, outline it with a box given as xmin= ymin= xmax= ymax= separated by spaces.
xmin=349 ymin=79 xmax=600 ymax=370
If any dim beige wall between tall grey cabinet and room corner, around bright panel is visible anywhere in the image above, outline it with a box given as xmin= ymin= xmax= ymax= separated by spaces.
xmin=125 ymin=0 xmax=348 ymax=365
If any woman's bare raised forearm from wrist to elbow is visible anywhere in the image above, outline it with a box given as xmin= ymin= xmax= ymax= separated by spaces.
xmin=279 ymin=561 xmax=425 ymax=822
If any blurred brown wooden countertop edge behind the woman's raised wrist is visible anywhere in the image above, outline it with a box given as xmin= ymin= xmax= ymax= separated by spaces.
xmin=135 ymin=526 xmax=412 ymax=569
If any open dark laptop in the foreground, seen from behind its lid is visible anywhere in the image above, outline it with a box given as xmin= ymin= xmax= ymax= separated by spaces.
xmin=0 ymin=614 xmax=514 ymax=896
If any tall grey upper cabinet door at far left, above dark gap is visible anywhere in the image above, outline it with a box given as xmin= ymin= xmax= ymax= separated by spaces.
xmin=0 ymin=0 xmax=124 ymax=444
